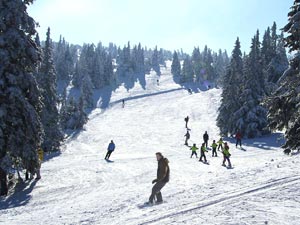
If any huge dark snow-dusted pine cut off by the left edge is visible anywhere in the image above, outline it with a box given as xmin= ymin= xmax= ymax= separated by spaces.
xmin=0 ymin=0 xmax=42 ymax=172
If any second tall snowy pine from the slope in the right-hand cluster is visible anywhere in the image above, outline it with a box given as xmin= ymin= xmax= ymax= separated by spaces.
xmin=234 ymin=31 xmax=268 ymax=138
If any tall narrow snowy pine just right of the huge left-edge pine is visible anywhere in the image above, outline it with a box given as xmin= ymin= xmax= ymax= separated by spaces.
xmin=37 ymin=28 xmax=63 ymax=152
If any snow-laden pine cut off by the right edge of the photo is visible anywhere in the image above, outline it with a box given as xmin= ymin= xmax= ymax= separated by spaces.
xmin=266 ymin=0 xmax=300 ymax=150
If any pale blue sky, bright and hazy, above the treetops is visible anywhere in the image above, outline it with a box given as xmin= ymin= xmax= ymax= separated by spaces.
xmin=28 ymin=0 xmax=294 ymax=53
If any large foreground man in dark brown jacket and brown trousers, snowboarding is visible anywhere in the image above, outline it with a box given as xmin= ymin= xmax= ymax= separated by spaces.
xmin=147 ymin=152 xmax=170 ymax=204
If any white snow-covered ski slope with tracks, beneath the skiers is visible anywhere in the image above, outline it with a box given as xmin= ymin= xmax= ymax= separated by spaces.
xmin=0 ymin=64 xmax=300 ymax=225
